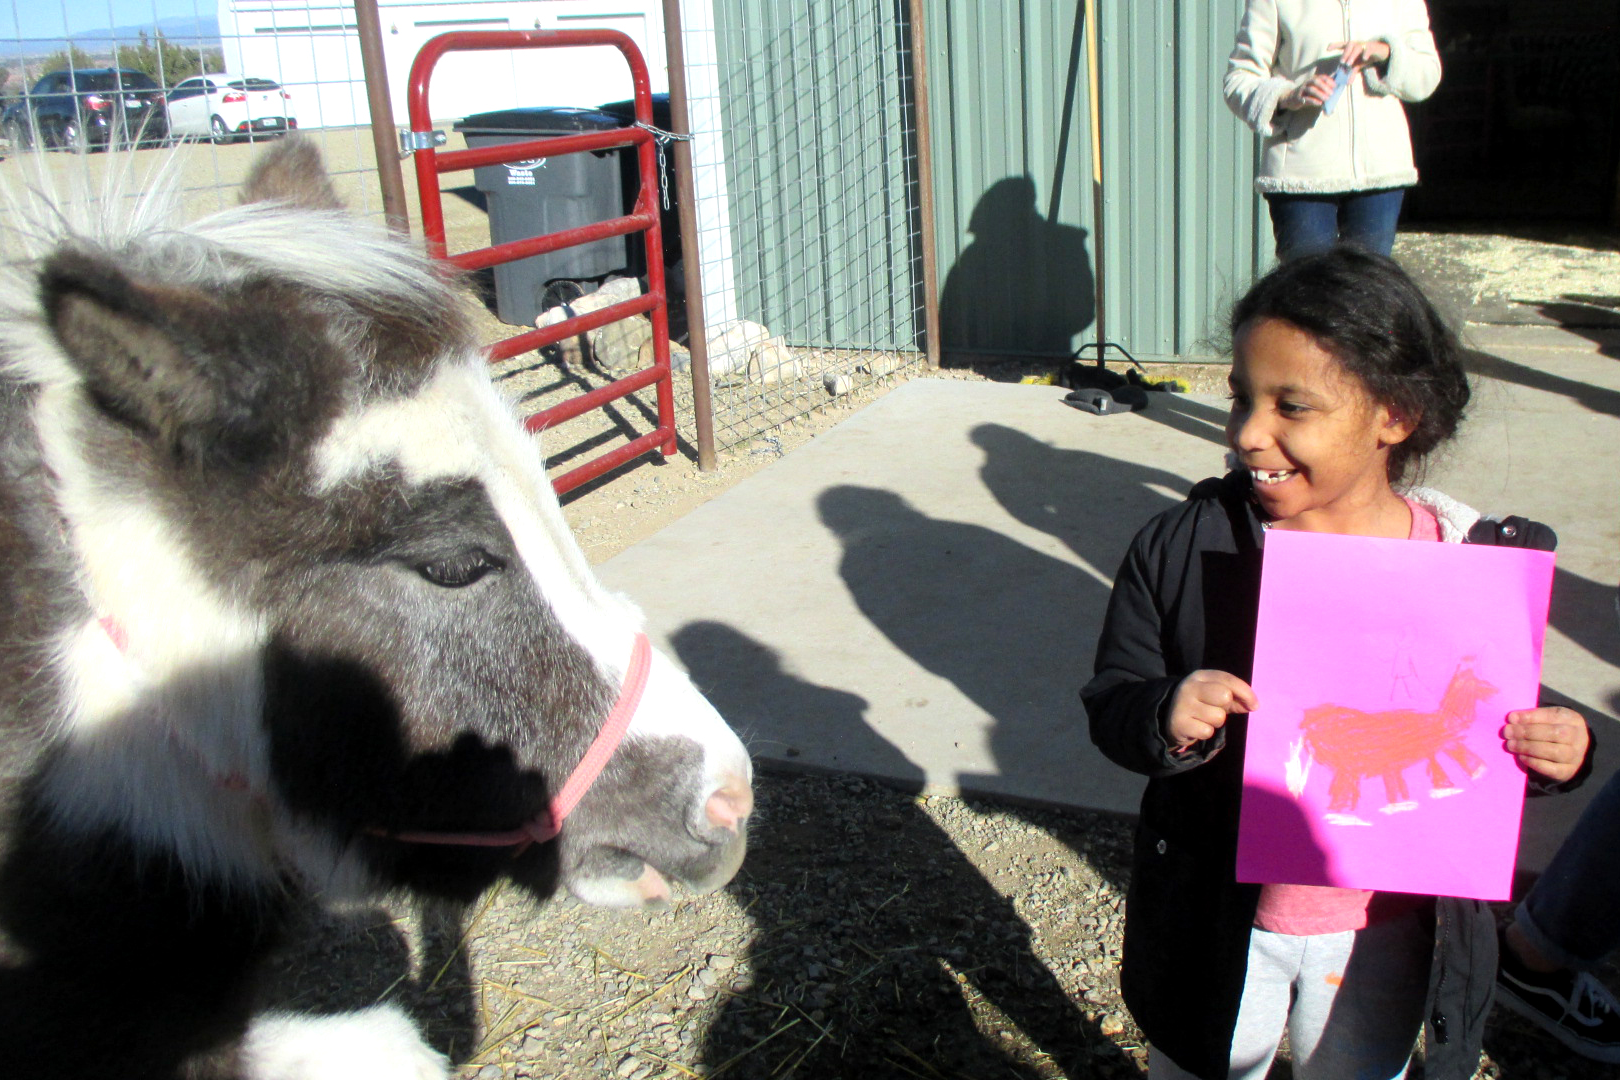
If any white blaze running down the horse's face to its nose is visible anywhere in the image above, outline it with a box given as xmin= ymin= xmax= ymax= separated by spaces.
xmin=316 ymin=356 xmax=753 ymax=799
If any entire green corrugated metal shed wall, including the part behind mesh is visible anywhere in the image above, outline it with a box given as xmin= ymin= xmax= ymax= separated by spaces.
xmin=714 ymin=0 xmax=1270 ymax=359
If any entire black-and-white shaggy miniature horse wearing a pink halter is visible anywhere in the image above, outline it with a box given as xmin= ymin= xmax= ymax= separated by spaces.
xmin=0 ymin=139 xmax=752 ymax=1080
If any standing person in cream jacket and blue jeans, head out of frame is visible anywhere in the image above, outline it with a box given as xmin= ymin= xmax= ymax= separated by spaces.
xmin=1223 ymin=0 xmax=1440 ymax=259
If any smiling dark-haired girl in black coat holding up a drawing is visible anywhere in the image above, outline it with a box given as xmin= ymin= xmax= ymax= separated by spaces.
xmin=1081 ymin=248 xmax=1591 ymax=1080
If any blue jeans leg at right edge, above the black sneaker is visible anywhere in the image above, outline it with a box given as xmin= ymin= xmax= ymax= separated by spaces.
xmin=1513 ymin=772 xmax=1620 ymax=970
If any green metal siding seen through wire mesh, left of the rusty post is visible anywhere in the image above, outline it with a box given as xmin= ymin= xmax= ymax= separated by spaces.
xmin=714 ymin=0 xmax=922 ymax=348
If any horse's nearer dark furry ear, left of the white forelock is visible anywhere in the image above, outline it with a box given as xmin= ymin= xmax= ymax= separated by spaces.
xmin=41 ymin=249 xmax=299 ymax=465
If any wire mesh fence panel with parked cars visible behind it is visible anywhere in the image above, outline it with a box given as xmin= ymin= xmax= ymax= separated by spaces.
xmin=0 ymin=0 xmax=400 ymax=234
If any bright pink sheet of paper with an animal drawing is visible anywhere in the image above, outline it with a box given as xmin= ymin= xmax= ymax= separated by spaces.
xmin=1238 ymin=529 xmax=1554 ymax=900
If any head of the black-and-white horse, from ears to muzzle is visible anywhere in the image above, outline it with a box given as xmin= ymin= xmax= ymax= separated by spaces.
xmin=0 ymin=139 xmax=752 ymax=905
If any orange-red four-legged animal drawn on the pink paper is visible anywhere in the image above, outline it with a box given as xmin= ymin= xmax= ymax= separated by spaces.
xmin=1299 ymin=664 xmax=1497 ymax=814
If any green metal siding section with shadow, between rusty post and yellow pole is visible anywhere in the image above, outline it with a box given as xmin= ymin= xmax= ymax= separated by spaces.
xmin=925 ymin=0 xmax=1094 ymax=355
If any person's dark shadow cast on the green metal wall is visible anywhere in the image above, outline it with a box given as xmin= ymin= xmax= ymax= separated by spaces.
xmin=940 ymin=176 xmax=1097 ymax=358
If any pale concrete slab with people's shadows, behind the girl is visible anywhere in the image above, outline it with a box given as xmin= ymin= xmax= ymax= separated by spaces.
xmin=599 ymin=329 xmax=1620 ymax=868
